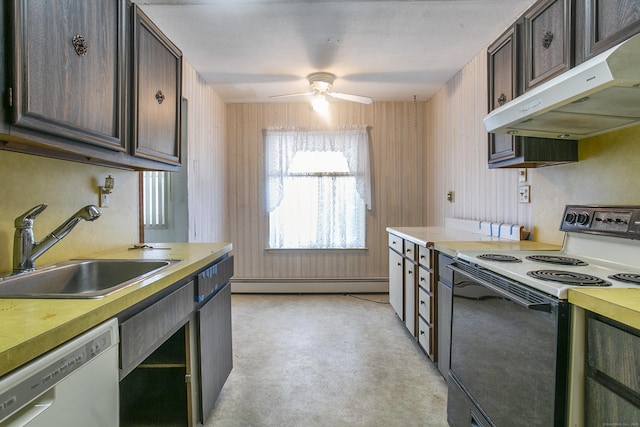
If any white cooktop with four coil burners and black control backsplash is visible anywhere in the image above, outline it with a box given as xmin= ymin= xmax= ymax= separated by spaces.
xmin=456 ymin=205 xmax=640 ymax=299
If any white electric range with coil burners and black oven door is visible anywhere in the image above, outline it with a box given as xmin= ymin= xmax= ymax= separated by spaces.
xmin=447 ymin=206 xmax=640 ymax=427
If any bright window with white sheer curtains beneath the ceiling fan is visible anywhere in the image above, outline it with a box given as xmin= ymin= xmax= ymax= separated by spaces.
xmin=265 ymin=128 xmax=371 ymax=249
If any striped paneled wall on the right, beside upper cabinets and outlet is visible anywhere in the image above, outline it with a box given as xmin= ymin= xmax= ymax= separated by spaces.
xmin=426 ymin=50 xmax=533 ymax=234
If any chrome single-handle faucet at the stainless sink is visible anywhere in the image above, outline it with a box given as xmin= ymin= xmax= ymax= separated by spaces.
xmin=13 ymin=203 xmax=102 ymax=274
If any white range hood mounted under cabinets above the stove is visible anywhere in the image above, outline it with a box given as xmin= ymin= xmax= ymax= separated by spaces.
xmin=484 ymin=34 xmax=640 ymax=140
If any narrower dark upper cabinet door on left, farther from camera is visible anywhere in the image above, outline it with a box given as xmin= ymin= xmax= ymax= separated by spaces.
xmin=131 ymin=5 xmax=182 ymax=165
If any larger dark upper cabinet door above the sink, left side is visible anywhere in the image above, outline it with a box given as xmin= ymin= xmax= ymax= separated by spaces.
xmin=5 ymin=0 xmax=126 ymax=151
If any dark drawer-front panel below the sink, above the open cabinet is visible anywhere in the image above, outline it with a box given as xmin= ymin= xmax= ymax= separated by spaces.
xmin=120 ymin=281 xmax=194 ymax=379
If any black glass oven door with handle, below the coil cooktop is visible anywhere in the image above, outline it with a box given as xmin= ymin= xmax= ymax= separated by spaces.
xmin=447 ymin=262 xmax=568 ymax=427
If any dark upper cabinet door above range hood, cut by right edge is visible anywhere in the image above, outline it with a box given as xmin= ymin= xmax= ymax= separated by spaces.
xmin=575 ymin=0 xmax=640 ymax=64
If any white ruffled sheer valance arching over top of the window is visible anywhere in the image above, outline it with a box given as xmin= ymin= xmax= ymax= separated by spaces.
xmin=263 ymin=127 xmax=371 ymax=212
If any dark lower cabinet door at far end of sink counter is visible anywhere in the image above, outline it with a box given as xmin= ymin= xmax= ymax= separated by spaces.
xmin=197 ymin=283 xmax=233 ymax=423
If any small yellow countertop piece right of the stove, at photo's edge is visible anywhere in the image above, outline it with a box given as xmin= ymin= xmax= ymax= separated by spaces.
xmin=569 ymin=288 xmax=640 ymax=329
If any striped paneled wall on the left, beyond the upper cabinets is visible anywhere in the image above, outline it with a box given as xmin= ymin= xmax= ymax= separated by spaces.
xmin=182 ymin=61 xmax=230 ymax=242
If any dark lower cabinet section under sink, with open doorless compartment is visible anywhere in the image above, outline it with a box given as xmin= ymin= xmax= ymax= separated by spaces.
xmin=118 ymin=255 xmax=233 ymax=426
